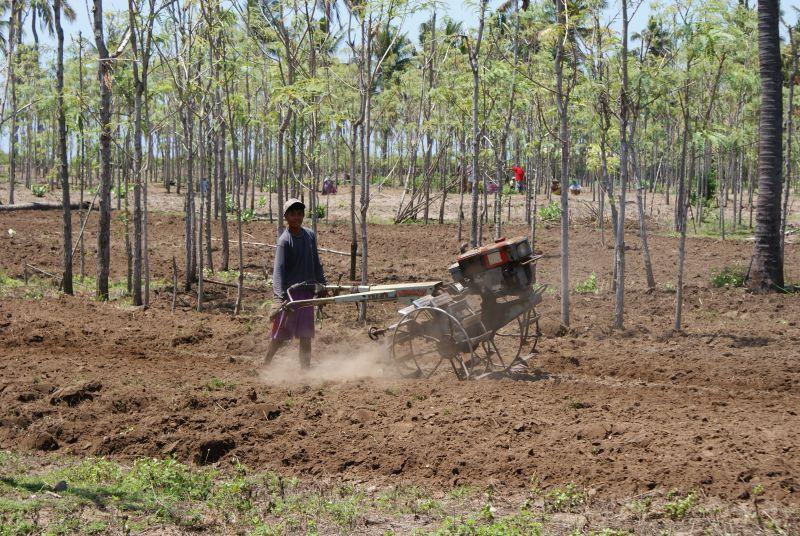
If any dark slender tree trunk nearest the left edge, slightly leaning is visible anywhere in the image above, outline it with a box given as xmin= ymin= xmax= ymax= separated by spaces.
xmin=53 ymin=0 xmax=73 ymax=294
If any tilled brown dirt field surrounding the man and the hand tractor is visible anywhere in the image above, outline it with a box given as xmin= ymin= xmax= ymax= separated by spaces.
xmin=0 ymin=200 xmax=800 ymax=532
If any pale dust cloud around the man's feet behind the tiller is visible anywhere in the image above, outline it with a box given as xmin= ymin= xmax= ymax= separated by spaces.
xmin=259 ymin=342 xmax=393 ymax=385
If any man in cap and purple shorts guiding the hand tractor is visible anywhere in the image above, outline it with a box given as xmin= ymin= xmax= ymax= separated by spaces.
xmin=264 ymin=199 xmax=325 ymax=369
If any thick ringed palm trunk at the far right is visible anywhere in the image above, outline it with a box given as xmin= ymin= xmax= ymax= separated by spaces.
xmin=748 ymin=0 xmax=784 ymax=292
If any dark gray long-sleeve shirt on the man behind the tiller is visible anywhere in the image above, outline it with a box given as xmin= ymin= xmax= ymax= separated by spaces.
xmin=272 ymin=227 xmax=327 ymax=300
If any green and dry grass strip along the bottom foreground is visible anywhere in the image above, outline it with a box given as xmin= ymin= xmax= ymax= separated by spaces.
xmin=0 ymin=452 xmax=796 ymax=536
